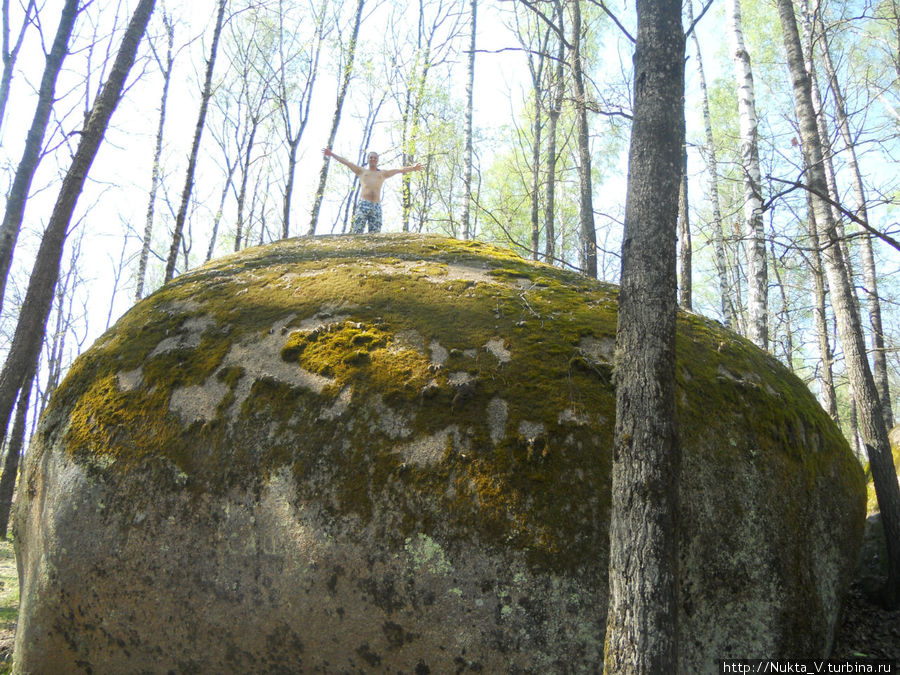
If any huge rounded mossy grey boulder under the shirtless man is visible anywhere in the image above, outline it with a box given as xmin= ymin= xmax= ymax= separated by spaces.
xmin=15 ymin=234 xmax=865 ymax=673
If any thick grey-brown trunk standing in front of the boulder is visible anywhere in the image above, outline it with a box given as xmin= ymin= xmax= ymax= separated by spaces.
xmin=605 ymin=0 xmax=684 ymax=675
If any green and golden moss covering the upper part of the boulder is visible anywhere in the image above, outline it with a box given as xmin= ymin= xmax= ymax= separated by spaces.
xmin=37 ymin=235 xmax=856 ymax=568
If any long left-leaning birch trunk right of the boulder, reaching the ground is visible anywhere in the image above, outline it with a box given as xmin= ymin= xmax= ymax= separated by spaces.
xmin=777 ymin=0 xmax=900 ymax=606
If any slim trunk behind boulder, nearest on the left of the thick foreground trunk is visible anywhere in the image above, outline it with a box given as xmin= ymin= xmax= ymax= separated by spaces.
xmin=571 ymin=0 xmax=597 ymax=278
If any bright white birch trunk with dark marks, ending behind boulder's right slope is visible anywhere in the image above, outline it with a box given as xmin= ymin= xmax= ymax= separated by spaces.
xmin=730 ymin=0 xmax=769 ymax=349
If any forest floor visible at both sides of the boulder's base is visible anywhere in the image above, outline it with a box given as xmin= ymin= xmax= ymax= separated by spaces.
xmin=0 ymin=540 xmax=900 ymax=675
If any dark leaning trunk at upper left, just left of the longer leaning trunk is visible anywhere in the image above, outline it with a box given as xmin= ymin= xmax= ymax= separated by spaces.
xmin=0 ymin=0 xmax=80 ymax=310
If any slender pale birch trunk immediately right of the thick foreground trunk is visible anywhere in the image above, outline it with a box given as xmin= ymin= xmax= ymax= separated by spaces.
xmin=685 ymin=0 xmax=737 ymax=330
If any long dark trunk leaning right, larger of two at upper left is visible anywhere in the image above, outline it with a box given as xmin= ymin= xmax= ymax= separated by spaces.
xmin=0 ymin=0 xmax=156 ymax=448
